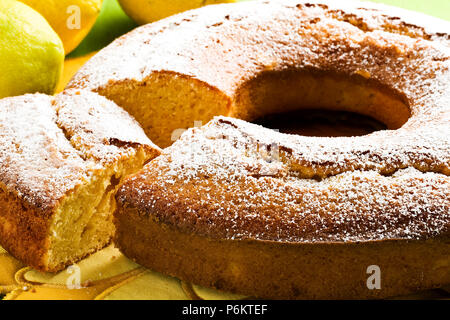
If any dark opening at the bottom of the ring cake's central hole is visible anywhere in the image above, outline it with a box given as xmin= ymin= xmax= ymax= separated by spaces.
xmin=252 ymin=109 xmax=387 ymax=137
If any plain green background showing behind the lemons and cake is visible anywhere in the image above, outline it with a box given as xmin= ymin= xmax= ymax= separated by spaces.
xmin=69 ymin=0 xmax=450 ymax=58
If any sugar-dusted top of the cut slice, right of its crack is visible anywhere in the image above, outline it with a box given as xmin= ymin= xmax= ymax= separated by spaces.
xmin=55 ymin=90 xmax=159 ymax=165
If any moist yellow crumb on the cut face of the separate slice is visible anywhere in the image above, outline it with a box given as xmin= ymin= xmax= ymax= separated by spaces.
xmin=48 ymin=149 xmax=148 ymax=270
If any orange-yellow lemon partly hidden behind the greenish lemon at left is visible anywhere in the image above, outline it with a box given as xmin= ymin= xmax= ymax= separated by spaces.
xmin=19 ymin=0 xmax=103 ymax=54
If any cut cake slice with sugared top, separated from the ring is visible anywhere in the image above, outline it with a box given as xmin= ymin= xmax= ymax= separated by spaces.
xmin=0 ymin=90 xmax=160 ymax=272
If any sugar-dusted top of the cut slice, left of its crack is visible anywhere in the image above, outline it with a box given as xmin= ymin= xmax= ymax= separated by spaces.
xmin=0 ymin=95 xmax=91 ymax=211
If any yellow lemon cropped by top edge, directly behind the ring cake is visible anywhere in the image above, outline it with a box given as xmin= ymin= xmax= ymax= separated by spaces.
xmin=119 ymin=0 xmax=237 ymax=24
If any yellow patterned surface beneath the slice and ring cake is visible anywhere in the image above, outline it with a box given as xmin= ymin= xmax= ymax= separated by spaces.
xmin=0 ymin=246 xmax=450 ymax=300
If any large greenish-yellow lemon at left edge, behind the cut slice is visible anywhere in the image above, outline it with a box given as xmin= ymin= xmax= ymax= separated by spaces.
xmin=0 ymin=0 xmax=64 ymax=98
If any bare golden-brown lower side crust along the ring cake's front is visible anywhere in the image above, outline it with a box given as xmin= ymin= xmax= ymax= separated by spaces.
xmin=115 ymin=208 xmax=450 ymax=299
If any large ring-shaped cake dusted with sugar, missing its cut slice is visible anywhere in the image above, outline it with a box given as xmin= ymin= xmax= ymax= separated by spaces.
xmin=69 ymin=0 xmax=450 ymax=298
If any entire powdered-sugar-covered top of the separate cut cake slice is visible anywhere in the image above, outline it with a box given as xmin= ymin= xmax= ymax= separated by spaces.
xmin=0 ymin=92 xmax=159 ymax=214
